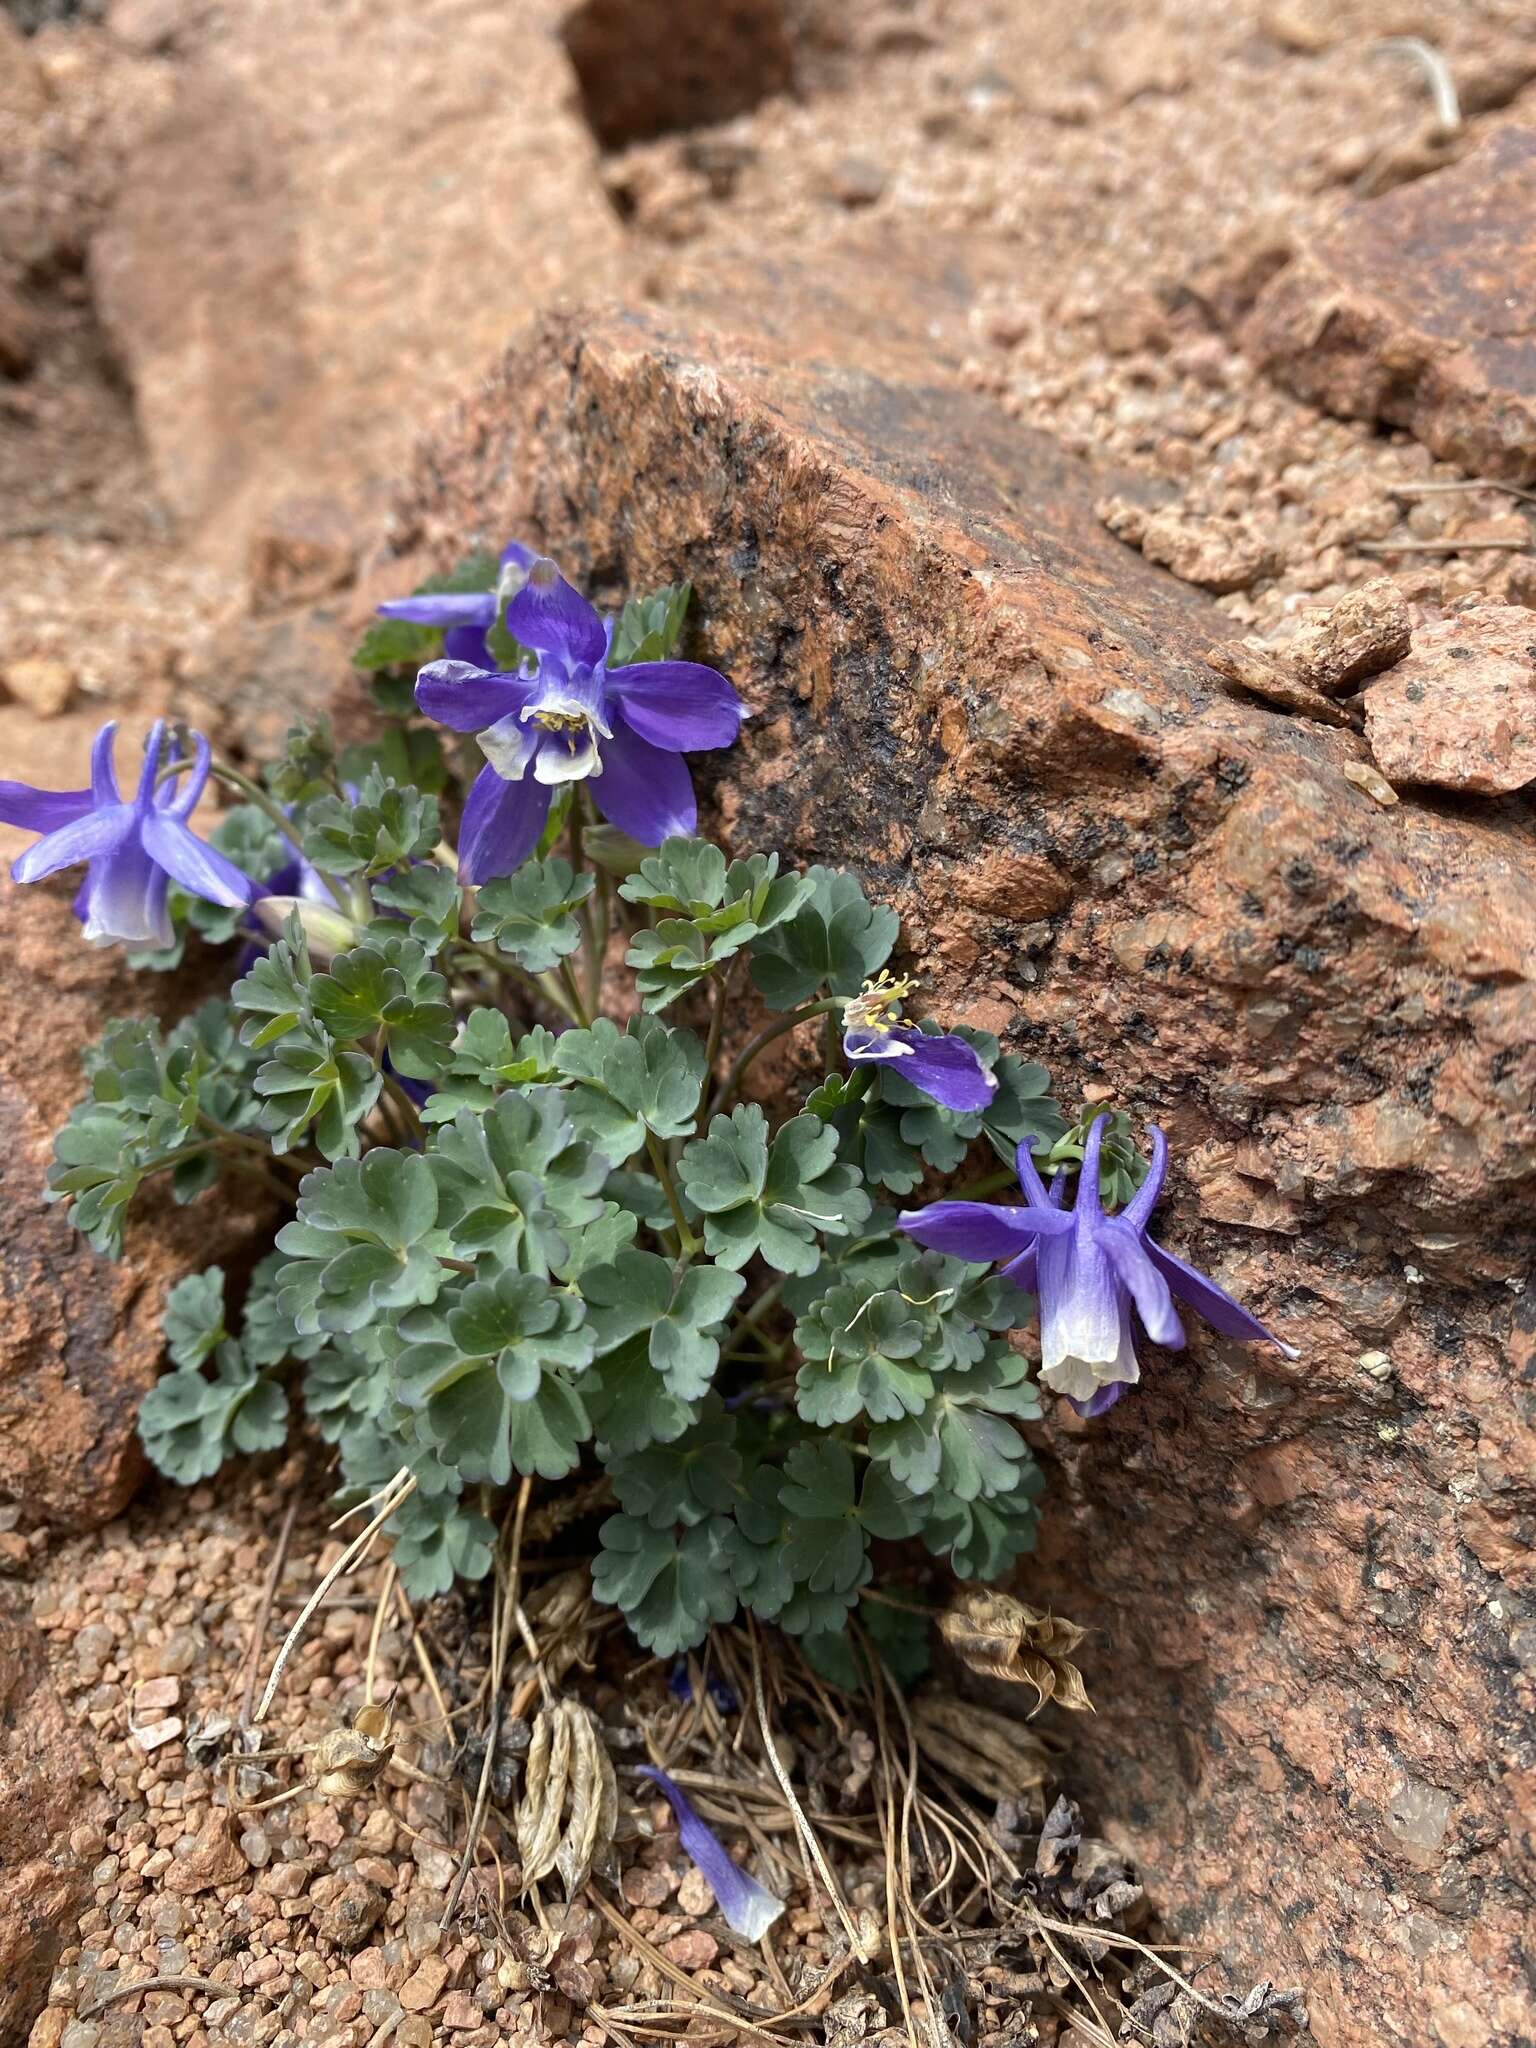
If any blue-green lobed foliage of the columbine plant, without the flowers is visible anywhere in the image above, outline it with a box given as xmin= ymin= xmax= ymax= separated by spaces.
xmin=49 ymin=598 xmax=1139 ymax=1654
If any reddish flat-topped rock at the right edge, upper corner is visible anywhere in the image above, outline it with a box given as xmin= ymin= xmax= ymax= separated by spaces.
xmin=1241 ymin=127 xmax=1536 ymax=483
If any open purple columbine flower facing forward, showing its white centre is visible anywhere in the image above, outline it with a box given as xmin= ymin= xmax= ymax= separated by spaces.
xmin=416 ymin=557 xmax=745 ymax=883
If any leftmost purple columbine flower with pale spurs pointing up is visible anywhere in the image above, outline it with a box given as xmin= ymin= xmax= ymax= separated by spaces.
xmin=0 ymin=719 xmax=256 ymax=948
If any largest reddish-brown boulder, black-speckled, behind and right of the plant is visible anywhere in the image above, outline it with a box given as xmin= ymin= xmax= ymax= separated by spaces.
xmin=391 ymin=256 xmax=1536 ymax=2048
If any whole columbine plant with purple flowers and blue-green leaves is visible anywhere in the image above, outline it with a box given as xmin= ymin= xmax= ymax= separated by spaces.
xmin=15 ymin=543 xmax=1266 ymax=1662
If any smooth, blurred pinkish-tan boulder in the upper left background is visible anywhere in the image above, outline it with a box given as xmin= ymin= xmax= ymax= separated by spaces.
xmin=90 ymin=0 xmax=623 ymax=557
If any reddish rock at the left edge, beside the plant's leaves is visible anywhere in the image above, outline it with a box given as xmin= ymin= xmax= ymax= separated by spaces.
xmin=0 ymin=872 xmax=268 ymax=1531
